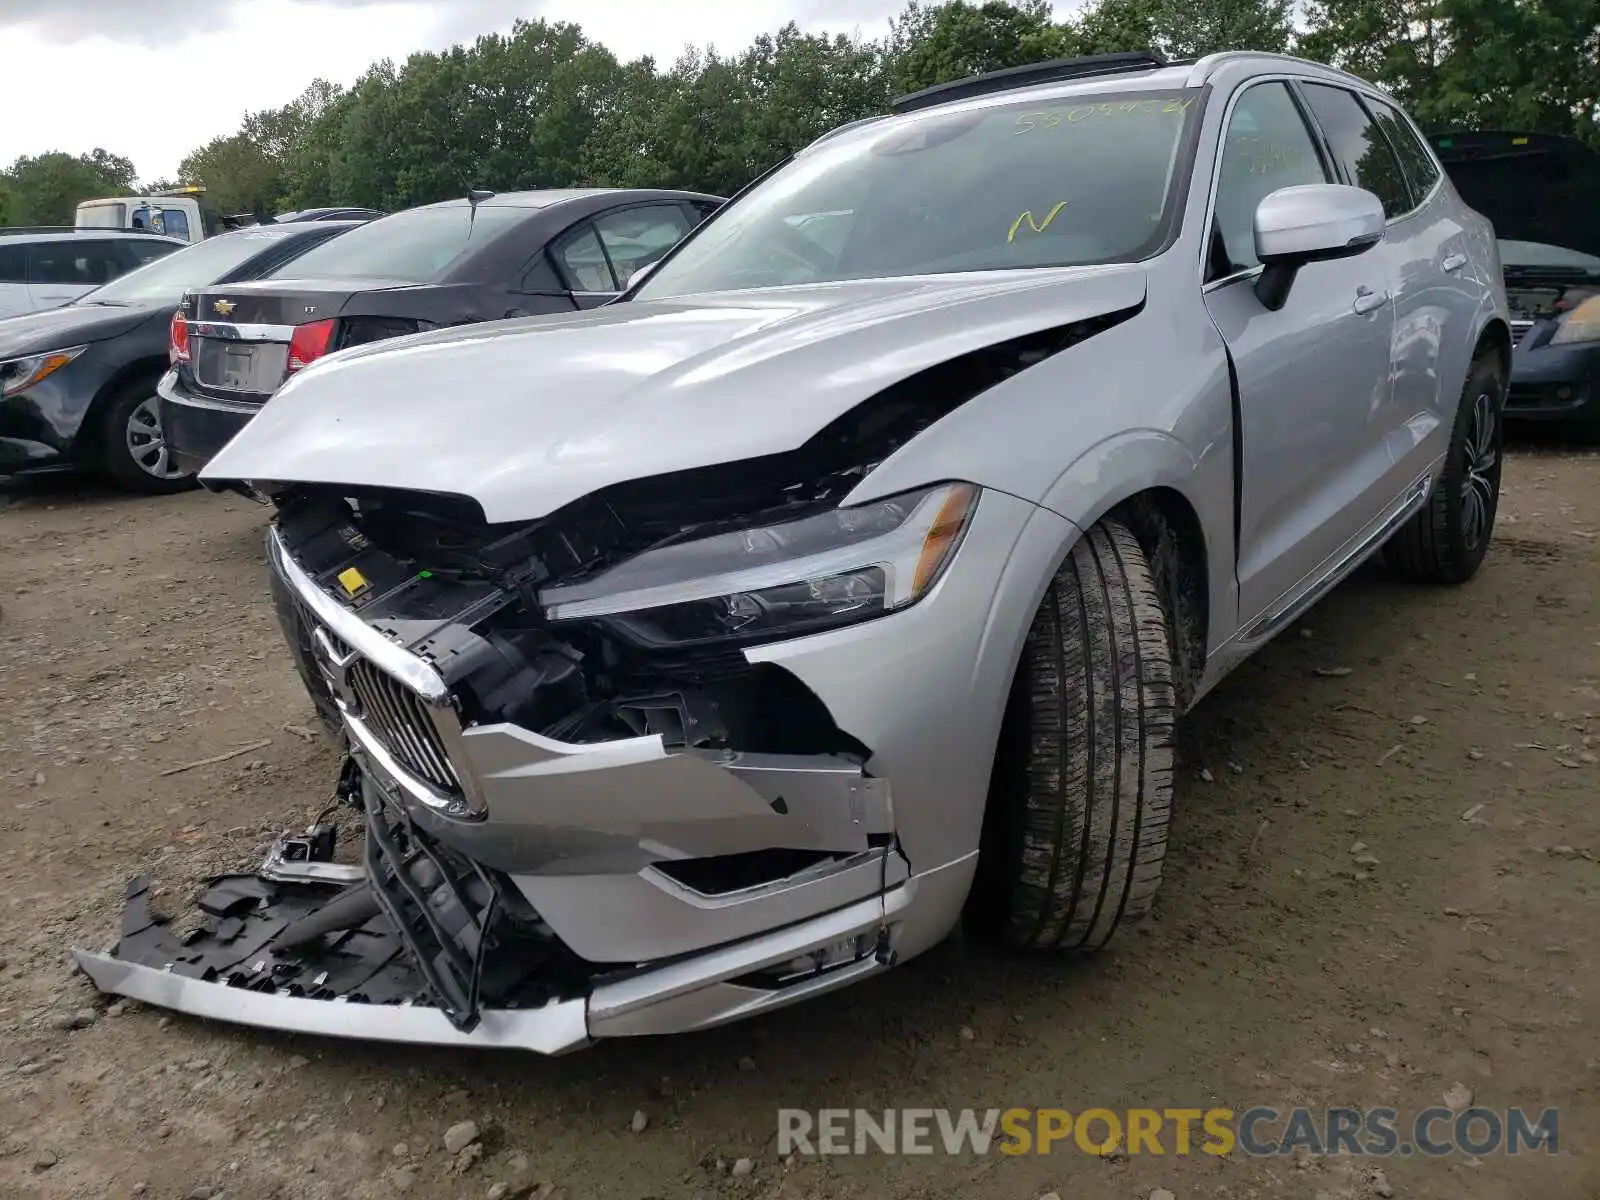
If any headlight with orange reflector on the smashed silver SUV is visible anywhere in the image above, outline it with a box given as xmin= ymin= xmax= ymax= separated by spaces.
xmin=539 ymin=483 xmax=978 ymax=646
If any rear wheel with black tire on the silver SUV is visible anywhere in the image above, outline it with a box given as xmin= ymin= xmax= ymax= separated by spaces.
xmin=1384 ymin=354 xmax=1506 ymax=584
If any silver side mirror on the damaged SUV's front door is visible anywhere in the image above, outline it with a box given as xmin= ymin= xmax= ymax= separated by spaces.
xmin=1256 ymin=184 xmax=1386 ymax=310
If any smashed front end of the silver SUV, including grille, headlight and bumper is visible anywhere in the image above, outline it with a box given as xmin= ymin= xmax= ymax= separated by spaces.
xmin=78 ymin=412 xmax=976 ymax=1053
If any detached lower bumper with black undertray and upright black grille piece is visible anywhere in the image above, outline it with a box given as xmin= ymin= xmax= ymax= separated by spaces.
xmin=74 ymin=761 xmax=915 ymax=1054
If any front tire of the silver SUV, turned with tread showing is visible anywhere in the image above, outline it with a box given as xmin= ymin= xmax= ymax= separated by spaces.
xmin=965 ymin=520 xmax=1176 ymax=950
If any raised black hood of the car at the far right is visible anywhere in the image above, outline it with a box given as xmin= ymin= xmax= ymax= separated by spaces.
xmin=1432 ymin=131 xmax=1600 ymax=256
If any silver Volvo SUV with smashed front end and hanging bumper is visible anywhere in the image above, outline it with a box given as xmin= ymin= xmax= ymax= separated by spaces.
xmin=78 ymin=54 xmax=1510 ymax=1053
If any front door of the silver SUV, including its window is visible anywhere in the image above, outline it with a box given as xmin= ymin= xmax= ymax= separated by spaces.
xmin=1205 ymin=80 xmax=1394 ymax=624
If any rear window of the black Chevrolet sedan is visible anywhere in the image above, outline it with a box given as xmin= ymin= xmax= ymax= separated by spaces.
xmin=272 ymin=205 xmax=530 ymax=283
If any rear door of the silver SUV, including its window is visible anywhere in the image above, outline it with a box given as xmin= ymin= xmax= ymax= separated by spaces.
xmin=1302 ymin=82 xmax=1478 ymax=490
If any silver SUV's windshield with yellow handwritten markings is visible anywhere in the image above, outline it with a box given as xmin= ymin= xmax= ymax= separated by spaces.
xmin=635 ymin=91 xmax=1200 ymax=299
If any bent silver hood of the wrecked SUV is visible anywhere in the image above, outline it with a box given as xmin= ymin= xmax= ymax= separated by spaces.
xmin=202 ymin=266 xmax=1146 ymax=522
